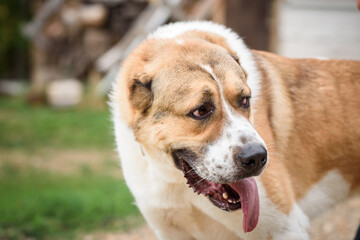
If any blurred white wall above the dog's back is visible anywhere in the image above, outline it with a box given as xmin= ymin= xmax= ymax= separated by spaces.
xmin=273 ymin=0 xmax=360 ymax=60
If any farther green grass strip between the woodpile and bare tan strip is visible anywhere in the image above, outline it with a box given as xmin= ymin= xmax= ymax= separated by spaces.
xmin=0 ymin=98 xmax=114 ymax=150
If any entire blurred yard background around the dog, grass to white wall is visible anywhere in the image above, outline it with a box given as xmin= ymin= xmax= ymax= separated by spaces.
xmin=0 ymin=0 xmax=360 ymax=240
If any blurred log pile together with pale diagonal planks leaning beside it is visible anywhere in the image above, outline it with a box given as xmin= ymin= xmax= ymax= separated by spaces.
xmin=24 ymin=0 xmax=225 ymax=104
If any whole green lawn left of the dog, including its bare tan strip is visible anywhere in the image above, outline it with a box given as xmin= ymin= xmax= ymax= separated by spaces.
xmin=0 ymin=98 xmax=141 ymax=239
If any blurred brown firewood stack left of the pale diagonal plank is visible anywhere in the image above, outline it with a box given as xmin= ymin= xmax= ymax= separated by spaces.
xmin=24 ymin=0 xmax=148 ymax=102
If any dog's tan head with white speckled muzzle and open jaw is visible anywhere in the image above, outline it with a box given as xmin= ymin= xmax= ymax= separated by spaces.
xmin=114 ymin=22 xmax=267 ymax=230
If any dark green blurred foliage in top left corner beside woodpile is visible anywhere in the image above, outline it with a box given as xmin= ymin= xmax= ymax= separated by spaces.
xmin=0 ymin=0 xmax=31 ymax=79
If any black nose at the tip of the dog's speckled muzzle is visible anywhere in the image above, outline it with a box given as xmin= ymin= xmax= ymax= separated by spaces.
xmin=235 ymin=143 xmax=267 ymax=172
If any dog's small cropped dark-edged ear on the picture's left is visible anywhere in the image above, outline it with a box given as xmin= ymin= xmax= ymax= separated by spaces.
xmin=129 ymin=74 xmax=153 ymax=112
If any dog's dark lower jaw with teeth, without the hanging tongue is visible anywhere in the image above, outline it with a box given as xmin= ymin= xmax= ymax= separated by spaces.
xmin=174 ymin=154 xmax=241 ymax=211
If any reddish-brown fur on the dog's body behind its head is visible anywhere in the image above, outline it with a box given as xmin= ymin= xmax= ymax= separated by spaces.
xmin=254 ymin=51 xmax=360 ymax=212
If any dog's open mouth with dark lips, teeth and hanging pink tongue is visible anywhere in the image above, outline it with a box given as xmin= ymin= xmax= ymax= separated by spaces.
xmin=176 ymin=156 xmax=259 ymax=233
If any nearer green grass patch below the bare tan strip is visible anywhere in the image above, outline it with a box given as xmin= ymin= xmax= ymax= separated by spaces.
xmin=0 ymin=167 xmax=138 ymax=239
